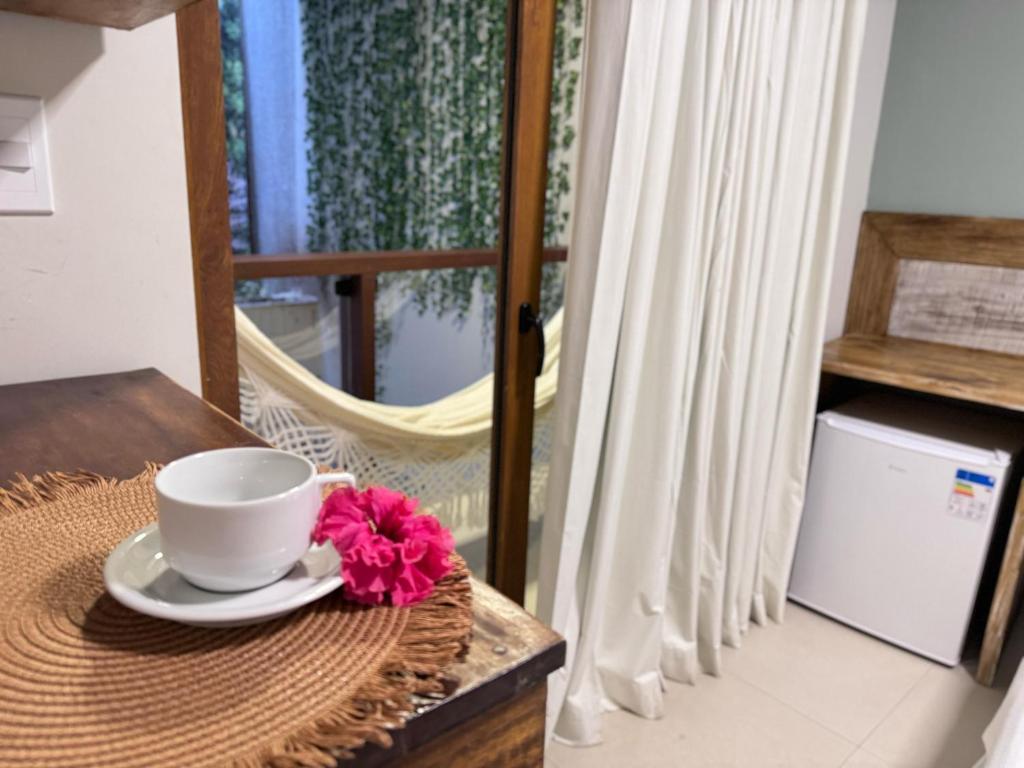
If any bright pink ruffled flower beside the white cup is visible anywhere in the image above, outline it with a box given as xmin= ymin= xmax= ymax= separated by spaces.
xmin=312 ymin=486 xmax=455 ymax=605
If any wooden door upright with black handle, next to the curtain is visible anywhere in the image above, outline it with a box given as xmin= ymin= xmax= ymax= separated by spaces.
xmin=487 ymin=0 xmax=555 ymax=605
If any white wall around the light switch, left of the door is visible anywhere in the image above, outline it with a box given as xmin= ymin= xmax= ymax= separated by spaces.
xmin=0 ymin=12 xmax=200 ymax=392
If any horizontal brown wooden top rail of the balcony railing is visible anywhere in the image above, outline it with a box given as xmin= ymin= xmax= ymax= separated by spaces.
xmin=234 ymin=248 xmax=567 ymax=280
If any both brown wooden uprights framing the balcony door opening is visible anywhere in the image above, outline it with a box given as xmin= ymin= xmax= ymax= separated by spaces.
xmin=177 ymin=0 xmax=556 ymax=604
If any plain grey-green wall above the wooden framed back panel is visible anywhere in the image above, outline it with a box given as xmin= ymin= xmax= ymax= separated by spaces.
xmin=868 ymin=0 xmax=1024 ymax=218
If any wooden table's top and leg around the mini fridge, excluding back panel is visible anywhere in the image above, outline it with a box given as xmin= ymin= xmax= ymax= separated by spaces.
xmin=821 ymin=334 xmax=1024 ymax=685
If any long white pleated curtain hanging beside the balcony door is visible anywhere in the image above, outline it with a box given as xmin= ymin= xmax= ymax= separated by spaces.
xmin=539 ymin=0 xmax=866 ymax=743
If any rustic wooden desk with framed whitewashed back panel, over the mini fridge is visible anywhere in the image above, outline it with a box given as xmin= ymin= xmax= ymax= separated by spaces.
xmin=821 ymin=212 xmax=1024 ymax=685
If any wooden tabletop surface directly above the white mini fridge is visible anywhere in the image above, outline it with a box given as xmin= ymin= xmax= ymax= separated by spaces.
xmin=821 ymin=335 xmax=1024 ymax=412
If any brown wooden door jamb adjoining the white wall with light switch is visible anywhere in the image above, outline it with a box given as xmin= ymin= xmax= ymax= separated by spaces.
xmin=177 ymin=0 xmax=239 ymax=419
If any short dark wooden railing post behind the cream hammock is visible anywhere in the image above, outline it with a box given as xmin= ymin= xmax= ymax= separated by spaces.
xmin=338 ymin=272 xmax=377 ymax=400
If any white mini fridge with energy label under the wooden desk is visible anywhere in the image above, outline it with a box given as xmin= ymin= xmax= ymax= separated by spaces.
xmin=790 ymin=394 xmax=1024 ymax=666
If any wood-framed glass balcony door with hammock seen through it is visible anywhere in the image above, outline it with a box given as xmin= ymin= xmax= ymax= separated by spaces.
xmin=178 ymin=0 xmax=573 ymax=600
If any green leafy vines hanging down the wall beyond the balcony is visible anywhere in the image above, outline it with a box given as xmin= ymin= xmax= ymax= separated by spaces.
xmin=301 ymin=0 xmax=584 ymax=358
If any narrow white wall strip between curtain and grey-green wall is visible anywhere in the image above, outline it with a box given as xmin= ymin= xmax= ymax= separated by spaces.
xmin=825 ymin=0 xmax=896 ymax=339
